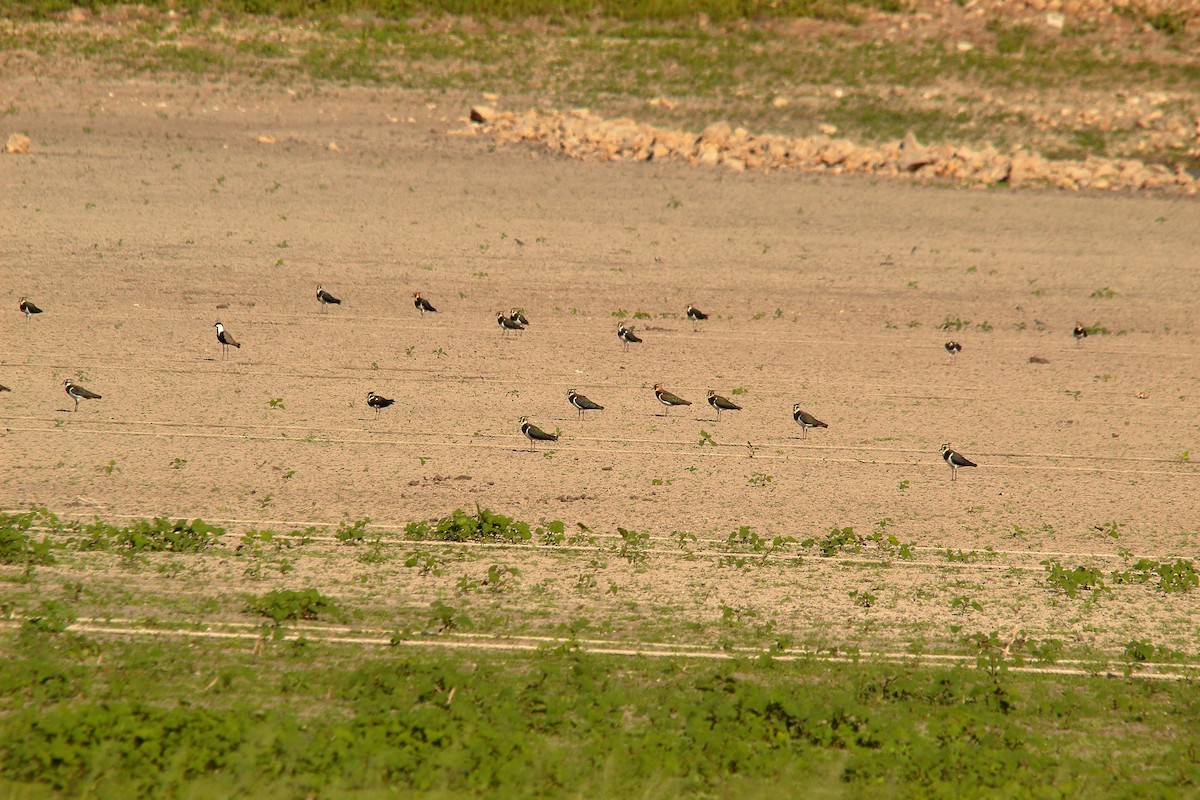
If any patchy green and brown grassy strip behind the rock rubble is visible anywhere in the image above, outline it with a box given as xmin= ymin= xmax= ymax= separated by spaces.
xmin=0 ymin=10 xmax=1200 ymax=164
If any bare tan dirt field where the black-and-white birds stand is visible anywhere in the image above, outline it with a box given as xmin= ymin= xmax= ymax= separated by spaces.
xmin=0 ymin=74 xmax=1200 ymax=654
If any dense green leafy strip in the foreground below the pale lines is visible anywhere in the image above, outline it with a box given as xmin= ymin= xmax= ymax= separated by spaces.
xmin=0 ymin=630 xmax=1200 ymax=798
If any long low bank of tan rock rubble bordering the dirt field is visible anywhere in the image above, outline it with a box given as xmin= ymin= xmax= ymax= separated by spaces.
xmin=463 ymin=106 xmax=1200 ymax=196
